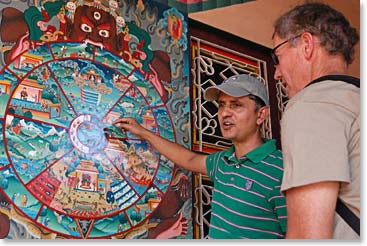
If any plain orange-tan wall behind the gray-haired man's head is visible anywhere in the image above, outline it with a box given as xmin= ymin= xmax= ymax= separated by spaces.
xmin=189 ymin=0 xmax=360 ymax=77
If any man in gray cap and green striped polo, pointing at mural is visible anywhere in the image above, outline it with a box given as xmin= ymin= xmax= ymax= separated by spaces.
xmin=115 ymin=74 xmax=287 ymax=239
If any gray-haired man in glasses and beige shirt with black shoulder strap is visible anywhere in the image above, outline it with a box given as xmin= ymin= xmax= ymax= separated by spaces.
xmin=272 ymin=0 xmax=360 ymax=239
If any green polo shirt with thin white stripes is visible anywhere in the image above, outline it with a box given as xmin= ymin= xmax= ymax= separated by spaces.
xmin=206 ymin=139 xmax=287 ymax=239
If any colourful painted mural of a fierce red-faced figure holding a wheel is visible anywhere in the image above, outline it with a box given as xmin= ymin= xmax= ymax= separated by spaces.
xmin=0 ymin=0 xmax=193 ymax=239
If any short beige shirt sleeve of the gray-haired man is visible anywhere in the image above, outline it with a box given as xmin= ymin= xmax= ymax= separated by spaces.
xmin=281 ymin=102 xmax=350 ymax=191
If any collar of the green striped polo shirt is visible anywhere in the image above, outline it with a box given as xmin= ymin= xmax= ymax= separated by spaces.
xmin=223 ymin=138 xmax=277 ymax=163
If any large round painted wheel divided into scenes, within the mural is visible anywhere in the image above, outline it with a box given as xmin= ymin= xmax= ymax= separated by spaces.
xmin=0 ymin=42 xmax=175 ymax=238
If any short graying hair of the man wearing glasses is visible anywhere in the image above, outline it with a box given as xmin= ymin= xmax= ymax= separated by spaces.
xmin=273 ymin=2 xmax=359 ymax=65
